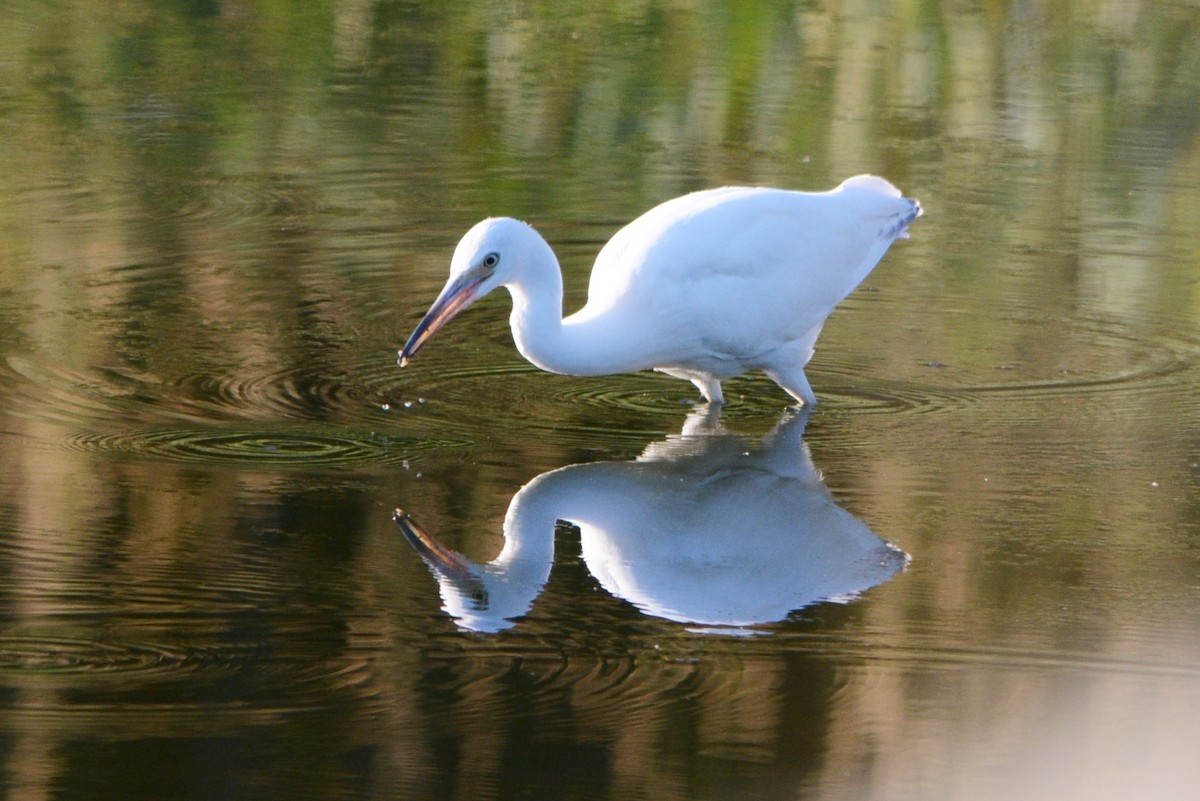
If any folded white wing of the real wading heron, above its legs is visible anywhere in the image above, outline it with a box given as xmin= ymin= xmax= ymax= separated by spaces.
xmin=584 ymin=183 xmax=917 ymax=362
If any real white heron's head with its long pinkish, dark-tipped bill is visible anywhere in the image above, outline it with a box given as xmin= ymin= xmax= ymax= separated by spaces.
xmin=398 ymin=217 xmax=545 ymax=367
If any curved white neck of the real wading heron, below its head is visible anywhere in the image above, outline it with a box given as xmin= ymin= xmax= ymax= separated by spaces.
xmin=508 ymin=251 xmax=637 ymax=375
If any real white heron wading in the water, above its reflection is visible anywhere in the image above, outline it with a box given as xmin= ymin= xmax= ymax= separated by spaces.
xmin=398 ymin=175 xmax=920 ymax=406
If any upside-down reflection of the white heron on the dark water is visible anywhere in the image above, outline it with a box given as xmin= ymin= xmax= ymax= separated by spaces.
xmin=395 ymin=408 xmax=908 ymax=632
